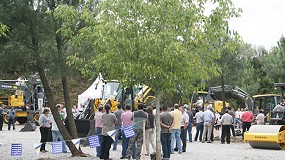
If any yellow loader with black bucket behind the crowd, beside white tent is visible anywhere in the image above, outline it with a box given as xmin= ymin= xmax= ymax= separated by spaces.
xmin=72 ymin=81 xmax=155 ymax=138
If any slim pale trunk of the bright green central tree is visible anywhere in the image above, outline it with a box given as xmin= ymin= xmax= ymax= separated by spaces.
xmin=155 ymin=95 xmax=162 ymax=159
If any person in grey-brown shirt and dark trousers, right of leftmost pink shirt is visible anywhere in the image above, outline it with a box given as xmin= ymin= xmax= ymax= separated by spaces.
xmin=100 ymin=104 xmax=117 ymax=159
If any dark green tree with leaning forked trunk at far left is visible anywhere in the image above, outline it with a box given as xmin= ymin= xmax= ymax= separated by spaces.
xmin=0 ymin=1 xmax=84 ymax=156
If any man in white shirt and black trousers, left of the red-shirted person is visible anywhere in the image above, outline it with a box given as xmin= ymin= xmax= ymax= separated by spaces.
xmin=221 ymin=110 xmax=233 ymax=144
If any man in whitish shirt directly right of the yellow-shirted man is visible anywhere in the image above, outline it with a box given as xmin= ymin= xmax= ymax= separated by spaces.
xmin=180 ymin=106 xmax=189 ymax=152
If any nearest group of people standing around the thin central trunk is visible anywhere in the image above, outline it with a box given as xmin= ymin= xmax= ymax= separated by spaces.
xmin=91 ymin=104 xmax=194 ymax=160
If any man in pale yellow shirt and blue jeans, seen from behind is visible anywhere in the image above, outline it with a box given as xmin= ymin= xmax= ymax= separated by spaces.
xmin=170 ymin=104 xmax=182 ymax=154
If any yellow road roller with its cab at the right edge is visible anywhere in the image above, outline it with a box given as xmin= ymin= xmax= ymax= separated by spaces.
xmin=244 ymin=83 xmax=285 ymax=150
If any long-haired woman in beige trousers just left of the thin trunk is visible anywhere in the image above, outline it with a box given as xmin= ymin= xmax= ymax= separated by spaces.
xmin=145 ymin=106 xmax=155 ymax=156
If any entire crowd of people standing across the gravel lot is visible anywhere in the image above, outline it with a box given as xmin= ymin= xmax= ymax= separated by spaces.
xmin=0 ymin=96 xmax=265 ymax=160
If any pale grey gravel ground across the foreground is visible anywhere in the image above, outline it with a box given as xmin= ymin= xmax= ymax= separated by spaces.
xmin=0 ymin=125 xmax=285 ymax=160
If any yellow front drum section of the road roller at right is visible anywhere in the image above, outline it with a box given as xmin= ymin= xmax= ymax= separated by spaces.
xmin=244 ymin=125 xmax=285 ymax=150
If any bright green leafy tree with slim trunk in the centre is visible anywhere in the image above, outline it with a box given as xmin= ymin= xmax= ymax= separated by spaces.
xmin=59 ymin=0 xmax=238 ymax=159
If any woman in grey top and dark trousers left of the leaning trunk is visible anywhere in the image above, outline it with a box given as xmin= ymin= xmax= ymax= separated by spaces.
xmin=39 ymin=108 xmax=51 ymax=153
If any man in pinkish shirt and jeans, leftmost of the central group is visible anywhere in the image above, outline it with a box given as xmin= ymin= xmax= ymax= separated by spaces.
xmin=95 ymin=106 xmax=104 ymax=157
